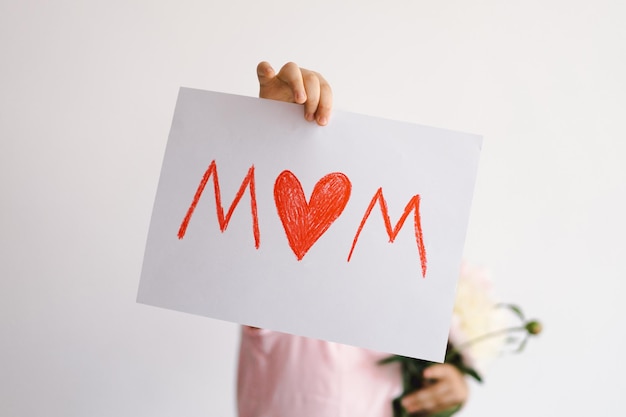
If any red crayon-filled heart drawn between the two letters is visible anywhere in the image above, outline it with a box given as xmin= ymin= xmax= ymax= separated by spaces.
xmin=274 ymin=171 xmax=352 ymax=261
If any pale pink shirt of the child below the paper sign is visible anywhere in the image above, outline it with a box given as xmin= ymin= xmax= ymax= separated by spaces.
xmin=237 ymin=326 xmax=402 ymax=417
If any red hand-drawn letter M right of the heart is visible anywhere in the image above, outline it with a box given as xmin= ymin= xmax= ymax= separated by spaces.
xmin=348 ymin=187 xmax=427 ymax=278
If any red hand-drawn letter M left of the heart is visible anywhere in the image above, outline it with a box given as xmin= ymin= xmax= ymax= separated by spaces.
xmin=178 ymin=160 xmax=261 ymax=249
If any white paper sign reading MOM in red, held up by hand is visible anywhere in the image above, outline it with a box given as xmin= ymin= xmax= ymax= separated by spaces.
xmin=138 ymin=88 xmax=481 ymax=361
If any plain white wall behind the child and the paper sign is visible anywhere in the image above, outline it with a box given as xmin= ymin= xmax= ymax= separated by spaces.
xmin=0 ymin=0 xmax=626 ymax=417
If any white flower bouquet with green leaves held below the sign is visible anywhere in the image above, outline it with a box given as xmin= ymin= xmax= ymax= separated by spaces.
xmin=380 ymin=265 xmax=541 ymax=417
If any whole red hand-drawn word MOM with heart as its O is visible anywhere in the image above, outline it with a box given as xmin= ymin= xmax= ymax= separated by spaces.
xmin=178 ymin=160 xmax=427 ymax=277
